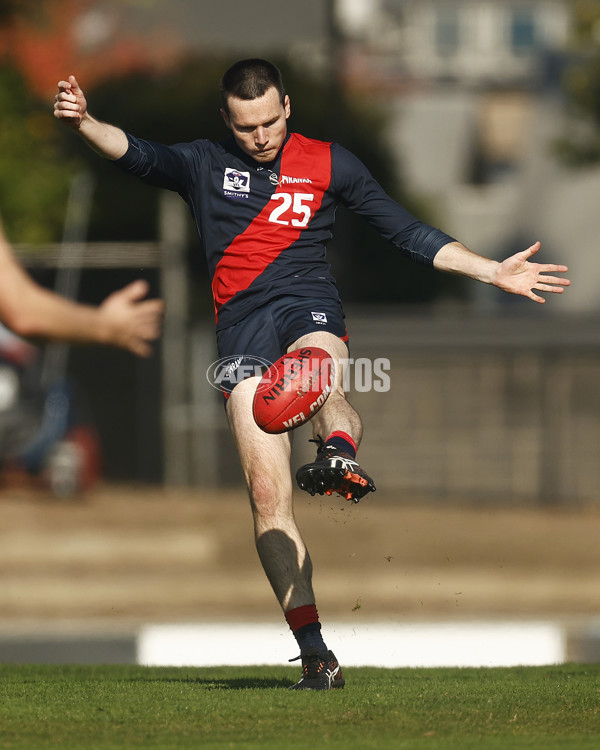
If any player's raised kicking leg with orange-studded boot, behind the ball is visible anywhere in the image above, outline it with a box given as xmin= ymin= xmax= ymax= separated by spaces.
xmin=289 ymin=331 xmax=375 ymax=503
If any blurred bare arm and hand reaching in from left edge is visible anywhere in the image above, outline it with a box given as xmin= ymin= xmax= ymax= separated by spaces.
xmin=0 ymin=219 xmax=164 ymax=357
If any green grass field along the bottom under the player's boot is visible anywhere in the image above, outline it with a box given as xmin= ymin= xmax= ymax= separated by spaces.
xmin=0 ymin=664 xmax=600 ymax=750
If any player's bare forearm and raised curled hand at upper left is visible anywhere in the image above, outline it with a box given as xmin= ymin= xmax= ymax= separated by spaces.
xmin=54 ymin=76 xmax=129 ymax=160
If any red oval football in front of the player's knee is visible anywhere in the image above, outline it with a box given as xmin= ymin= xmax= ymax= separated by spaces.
xmin=252 ymin=346 xmax=335 ymax=434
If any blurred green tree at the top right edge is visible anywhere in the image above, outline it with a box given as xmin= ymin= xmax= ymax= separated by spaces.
xmin=557 ymin=0 xmax=600 ymax=166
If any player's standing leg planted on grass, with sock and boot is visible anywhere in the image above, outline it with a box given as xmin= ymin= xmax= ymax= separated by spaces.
xmin=227 ymin=378 xmax=344 ymax=690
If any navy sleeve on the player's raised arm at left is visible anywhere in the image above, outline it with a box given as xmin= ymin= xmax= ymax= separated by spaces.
xmin=113 ymin=133 xmax=202 ymax=194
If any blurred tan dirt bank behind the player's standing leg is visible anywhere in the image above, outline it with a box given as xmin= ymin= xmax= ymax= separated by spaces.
xmin=0 ymin=486 xmax=600 ymax=625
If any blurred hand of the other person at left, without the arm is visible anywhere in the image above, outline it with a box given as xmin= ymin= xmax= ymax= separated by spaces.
xmin=99 ymin=279 xmax=165 ymax=357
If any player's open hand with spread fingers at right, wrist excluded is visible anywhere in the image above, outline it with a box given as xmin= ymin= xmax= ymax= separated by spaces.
xmin=494 ymin=242 xmax=571 ymax=303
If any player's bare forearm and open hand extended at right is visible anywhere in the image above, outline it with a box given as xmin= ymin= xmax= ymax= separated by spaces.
xmin=433 ymin=242 xmax=571 ymax=303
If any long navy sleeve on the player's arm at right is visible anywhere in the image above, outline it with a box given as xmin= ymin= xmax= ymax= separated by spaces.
xmin=331 ymin=143 xmax=454 ymax=266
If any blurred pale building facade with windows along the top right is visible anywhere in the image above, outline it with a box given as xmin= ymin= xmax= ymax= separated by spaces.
xmin=338 ymin=0 xmax=571 ymax=87
